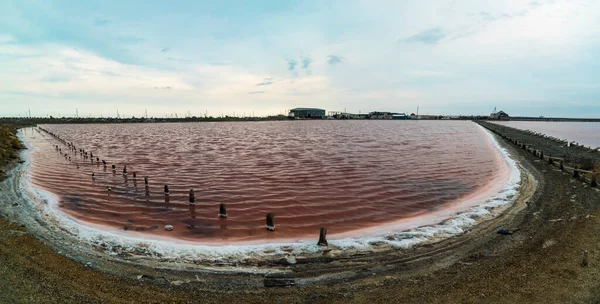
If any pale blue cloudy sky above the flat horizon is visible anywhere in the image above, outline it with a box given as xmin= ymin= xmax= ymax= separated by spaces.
xmin=0 ymin=0 xmax=600 ymax=117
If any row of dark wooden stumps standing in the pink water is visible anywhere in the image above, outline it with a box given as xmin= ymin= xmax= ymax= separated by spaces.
xmin=38 ymin=127 xmax=328 ymax=246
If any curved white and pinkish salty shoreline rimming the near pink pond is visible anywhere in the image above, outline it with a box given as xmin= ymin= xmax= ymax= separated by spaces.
xmin=8 ymin=123 xmax=520 ymax=264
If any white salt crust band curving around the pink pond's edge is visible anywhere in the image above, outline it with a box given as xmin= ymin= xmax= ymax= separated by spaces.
xmin=7 ymin=123 xmax=521 ymax=273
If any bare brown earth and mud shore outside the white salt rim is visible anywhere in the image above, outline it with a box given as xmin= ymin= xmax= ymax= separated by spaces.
xmin=0 ymin=122 xmax=600 ymax=303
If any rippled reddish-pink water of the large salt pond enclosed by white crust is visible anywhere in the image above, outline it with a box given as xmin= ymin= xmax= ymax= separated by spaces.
xmin=25 ymin=121 xmax=498 ymax=241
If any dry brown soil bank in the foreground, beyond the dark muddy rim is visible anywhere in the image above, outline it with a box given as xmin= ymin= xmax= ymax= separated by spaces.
xmin=0 ymin=123 xmax=600 ymax=303
